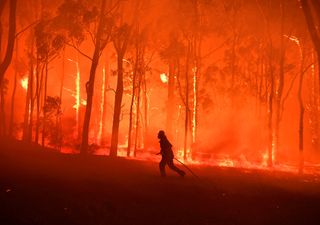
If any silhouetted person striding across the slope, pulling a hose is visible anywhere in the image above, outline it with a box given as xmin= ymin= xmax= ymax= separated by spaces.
xmin=158 ymin=130 xmax=186 ymax=177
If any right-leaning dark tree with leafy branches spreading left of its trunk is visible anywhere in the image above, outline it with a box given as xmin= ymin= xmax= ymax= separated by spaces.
xmin=56 ymin=0 xmax=117 ymax=154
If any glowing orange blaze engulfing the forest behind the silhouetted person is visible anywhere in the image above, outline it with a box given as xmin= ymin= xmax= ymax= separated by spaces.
xmin=0 ymin=0 xmax=320 ymax=176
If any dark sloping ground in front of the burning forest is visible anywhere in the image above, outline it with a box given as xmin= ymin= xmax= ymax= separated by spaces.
xmin=0 ymin=140 xmax=320 ymax=225
